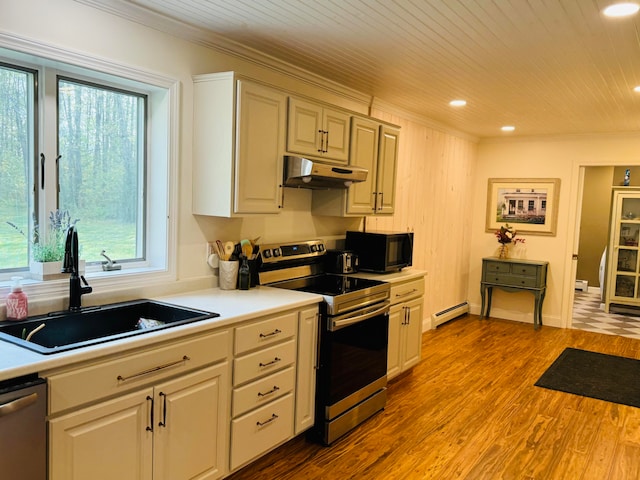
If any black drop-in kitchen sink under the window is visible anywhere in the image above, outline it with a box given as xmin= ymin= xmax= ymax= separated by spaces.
xmin=0 ymin=300 xmax=220 ymax=355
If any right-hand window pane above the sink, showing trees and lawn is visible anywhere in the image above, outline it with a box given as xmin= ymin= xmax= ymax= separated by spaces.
xmin=56 ymin=76 xmax=147 ymax=263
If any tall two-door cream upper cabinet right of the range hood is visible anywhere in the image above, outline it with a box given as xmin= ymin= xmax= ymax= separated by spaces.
xmin=312 ymin=117 xmax=400 ymax=217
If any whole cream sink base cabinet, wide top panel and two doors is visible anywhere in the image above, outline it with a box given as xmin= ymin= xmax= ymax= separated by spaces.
xmin=49 ymin=332 xmax=229 ymax=480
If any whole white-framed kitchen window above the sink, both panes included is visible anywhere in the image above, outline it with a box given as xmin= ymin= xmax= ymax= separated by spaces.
xmin=0 ymin=48 xmax=177 ymax=290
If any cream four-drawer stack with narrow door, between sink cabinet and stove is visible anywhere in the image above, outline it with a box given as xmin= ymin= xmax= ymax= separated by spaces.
xmin=230 ymin=307 xmax=318 ymax=471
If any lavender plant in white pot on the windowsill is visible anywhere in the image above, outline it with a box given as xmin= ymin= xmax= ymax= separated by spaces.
xmin=7 ymin=210 xmax=85 ymax=280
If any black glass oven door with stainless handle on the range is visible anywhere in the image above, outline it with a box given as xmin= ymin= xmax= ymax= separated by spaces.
xmin=317 ymin=301 xmax=389 ymax=408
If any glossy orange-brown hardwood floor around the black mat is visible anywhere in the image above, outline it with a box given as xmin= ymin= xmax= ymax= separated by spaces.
xmin=229 ymin=315 xmax=640 ymax=480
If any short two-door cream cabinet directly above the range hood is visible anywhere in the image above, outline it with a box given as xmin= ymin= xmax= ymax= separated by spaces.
xmin=287 ymin=97 xmax=351 ymax=164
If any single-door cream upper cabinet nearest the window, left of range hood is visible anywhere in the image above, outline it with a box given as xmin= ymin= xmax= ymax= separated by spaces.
xmin=193 ymin=72 xmax=287 ymax=217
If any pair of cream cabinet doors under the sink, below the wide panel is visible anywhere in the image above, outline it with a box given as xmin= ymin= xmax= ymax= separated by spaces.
xmin=49 ymin=363 xmax=228 ymax=480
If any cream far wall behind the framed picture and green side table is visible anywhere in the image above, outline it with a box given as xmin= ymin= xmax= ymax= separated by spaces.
xmin=468 ymin=133 xmax=640 ymax=327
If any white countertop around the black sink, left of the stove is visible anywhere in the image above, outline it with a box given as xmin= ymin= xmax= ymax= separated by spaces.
xmin=0 ymin=286 xmax=322 ymax=381
